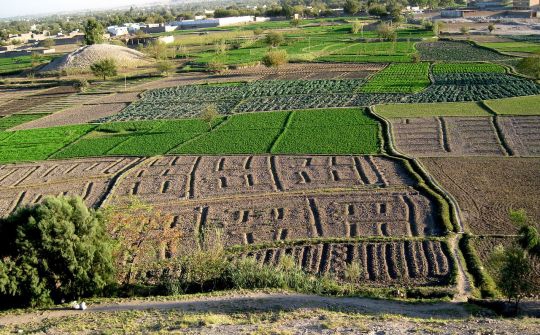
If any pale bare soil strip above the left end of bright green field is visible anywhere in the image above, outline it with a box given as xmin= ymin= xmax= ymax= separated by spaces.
xmin=13 ymin=102 xmax=127 ymax=130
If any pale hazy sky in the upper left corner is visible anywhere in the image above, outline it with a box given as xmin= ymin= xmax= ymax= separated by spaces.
xmin=0 ymin=0 xmax=155 ymax=17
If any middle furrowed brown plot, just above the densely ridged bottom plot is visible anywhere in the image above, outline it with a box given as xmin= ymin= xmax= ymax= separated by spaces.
xmin=156 ymin=190 xmax=441 ymax=246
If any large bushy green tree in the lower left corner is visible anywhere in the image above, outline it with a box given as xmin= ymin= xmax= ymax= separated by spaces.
xmin=0 ymin=197 xmax=114 ymax=306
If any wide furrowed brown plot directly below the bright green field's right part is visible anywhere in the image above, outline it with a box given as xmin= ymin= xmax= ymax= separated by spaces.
xmin=108 ymin=156 xmax=413 ymax=204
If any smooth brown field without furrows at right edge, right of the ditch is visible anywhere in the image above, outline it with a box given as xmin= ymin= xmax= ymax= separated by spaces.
xmin=421 ymin=157 xmax=540 ymax=234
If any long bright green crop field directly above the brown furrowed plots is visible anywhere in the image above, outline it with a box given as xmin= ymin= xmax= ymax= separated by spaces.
xmin=0 ymin=108 xmax=380 ymax=163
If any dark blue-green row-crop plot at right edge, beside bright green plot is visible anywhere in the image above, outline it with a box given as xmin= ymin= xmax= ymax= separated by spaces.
xmin=407 ymin=73 xmax=540 ymax=103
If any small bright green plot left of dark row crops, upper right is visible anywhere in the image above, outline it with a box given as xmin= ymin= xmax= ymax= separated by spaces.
xmin=360 ymin=63 xmax=430 ymax=93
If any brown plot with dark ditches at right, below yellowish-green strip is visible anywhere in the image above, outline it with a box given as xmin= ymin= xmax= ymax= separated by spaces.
xmin=390 ymin=116 xmax=540 ymax=157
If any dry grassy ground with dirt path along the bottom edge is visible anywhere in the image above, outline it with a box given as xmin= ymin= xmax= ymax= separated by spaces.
xmin=0 ymin=293 xmax=540 ymax=335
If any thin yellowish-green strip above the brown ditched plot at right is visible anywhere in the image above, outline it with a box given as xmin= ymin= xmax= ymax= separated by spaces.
xmin=374 ymin=102 xmax=490 ymax=118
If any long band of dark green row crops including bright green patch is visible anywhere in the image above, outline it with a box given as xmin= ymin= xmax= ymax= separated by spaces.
xmin=98 ymin=68 xmax=540 ymax=122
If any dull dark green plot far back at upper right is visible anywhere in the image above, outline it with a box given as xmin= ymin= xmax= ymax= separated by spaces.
xmin=416 ymin=41 xmax=512 ymax=62
